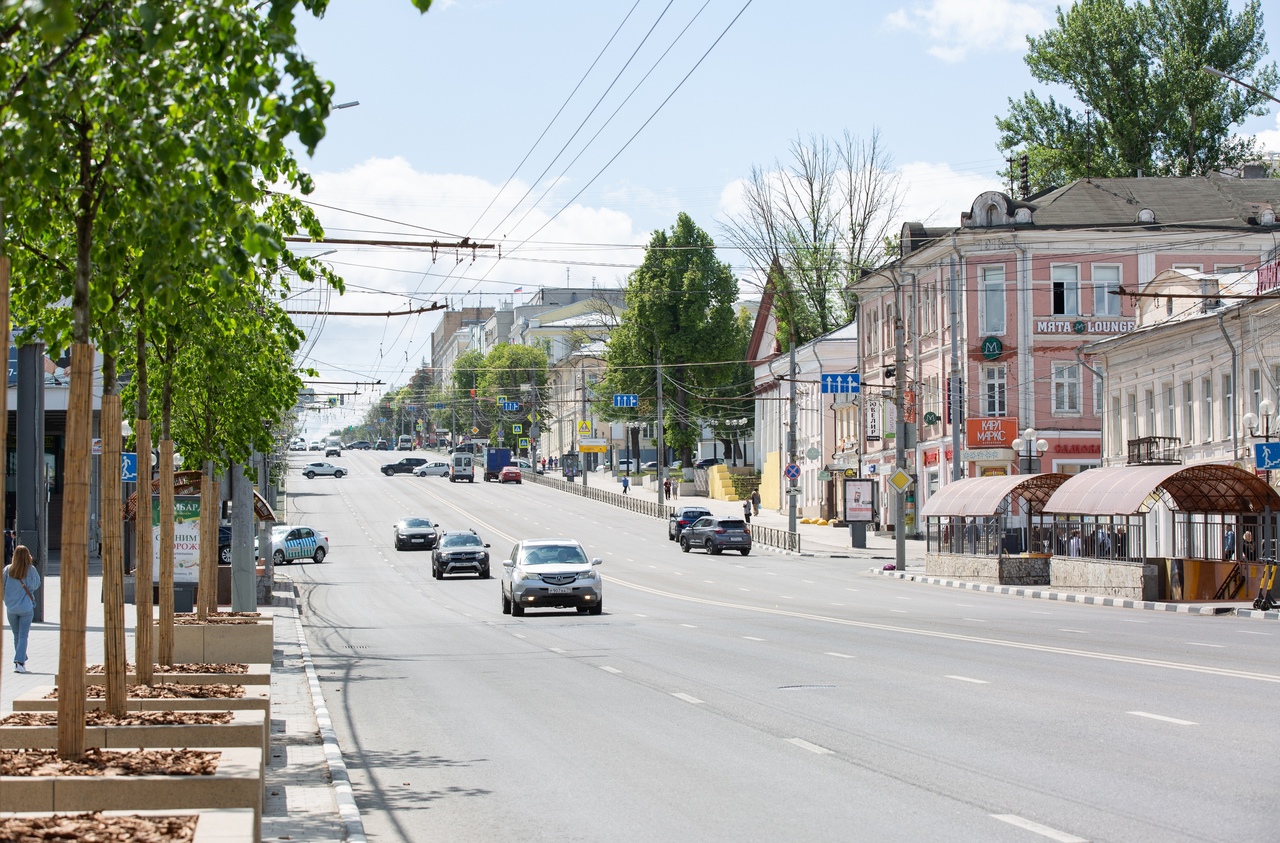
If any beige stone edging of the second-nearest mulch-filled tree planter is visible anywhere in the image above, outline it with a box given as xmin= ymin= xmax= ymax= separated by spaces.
xmin=0 ymin=747 xmax=262 ymax=842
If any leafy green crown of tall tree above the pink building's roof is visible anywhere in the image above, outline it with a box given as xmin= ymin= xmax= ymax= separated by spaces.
xmin=996 ymin=0 xmax=1277 ymax=192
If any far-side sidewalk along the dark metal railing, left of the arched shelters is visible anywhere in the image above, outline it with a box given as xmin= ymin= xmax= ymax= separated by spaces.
xmin=575 ymin=471 xmax=924 ymax=562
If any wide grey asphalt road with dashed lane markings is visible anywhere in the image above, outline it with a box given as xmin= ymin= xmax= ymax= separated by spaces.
xmin=282 ymin=452 xmax=1280 ymax=843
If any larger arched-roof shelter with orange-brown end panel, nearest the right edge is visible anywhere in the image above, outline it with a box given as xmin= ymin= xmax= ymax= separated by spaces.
xmin=1044 ymin=464 xmax=1280 ymax=601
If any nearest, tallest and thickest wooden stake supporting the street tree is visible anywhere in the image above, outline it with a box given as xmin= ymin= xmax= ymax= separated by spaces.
xmin=58 ymin=343 xmax=93 ymax=759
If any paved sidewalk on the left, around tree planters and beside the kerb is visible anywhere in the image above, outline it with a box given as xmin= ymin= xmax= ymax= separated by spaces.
xmin=0 ymin=551 xmax=350 ymax=842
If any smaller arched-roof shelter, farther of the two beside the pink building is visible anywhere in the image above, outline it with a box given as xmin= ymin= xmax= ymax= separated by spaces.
xmin=920 ymin=473 xmax=1071 ymax=586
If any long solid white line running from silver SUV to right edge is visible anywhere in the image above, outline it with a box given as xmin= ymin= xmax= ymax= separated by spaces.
xmin=607 ymin=577 xmax=1280 ymax=684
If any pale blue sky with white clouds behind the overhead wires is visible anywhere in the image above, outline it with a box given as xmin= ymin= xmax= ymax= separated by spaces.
xmin=290 ymin=0 xmax=1280 ymax=430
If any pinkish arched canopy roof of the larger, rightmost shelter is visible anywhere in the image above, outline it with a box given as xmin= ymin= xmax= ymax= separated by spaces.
xmin=1044 ymin=464 xmax=1280 ymax=516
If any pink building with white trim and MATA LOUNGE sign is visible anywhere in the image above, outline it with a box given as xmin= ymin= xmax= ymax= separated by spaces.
xmin=854 ymin=175 xmax=1280 ymax=535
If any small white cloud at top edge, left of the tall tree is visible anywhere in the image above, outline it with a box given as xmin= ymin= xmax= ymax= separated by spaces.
xmin=884 ymin=0 xmax=1056 ymax=63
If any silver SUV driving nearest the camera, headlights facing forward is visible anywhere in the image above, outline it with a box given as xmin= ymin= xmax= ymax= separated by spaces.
xmin=502 ymin=539 xmax=604 ymax=618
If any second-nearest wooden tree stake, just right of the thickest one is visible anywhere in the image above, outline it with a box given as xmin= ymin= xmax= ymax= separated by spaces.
xmin=99 ymin=393 xmax=128 ymax=716
